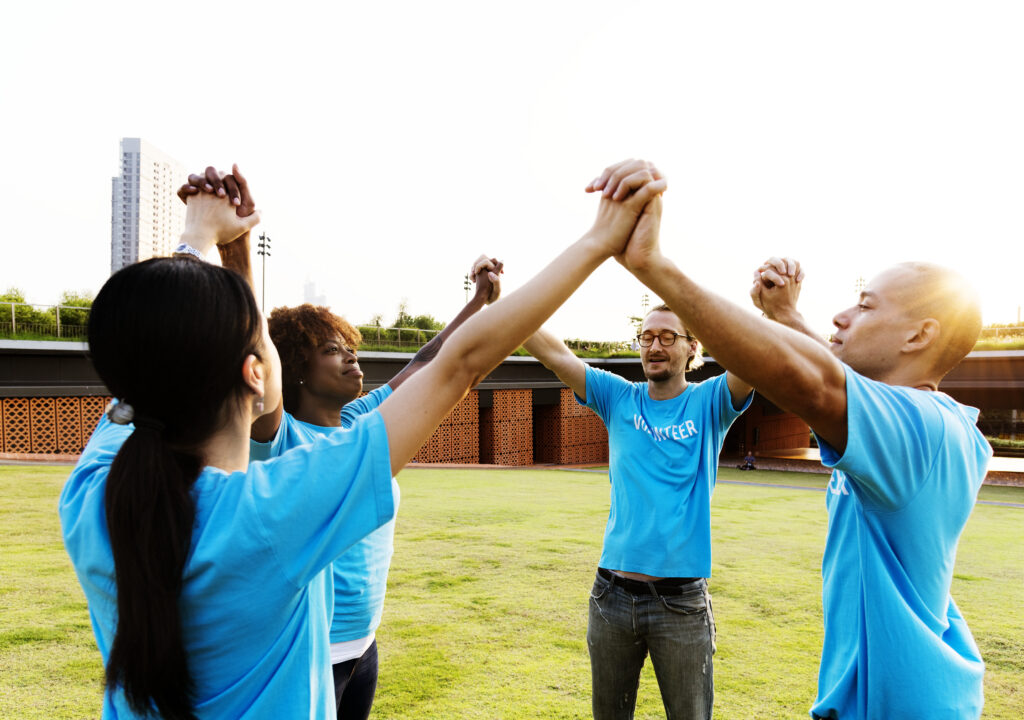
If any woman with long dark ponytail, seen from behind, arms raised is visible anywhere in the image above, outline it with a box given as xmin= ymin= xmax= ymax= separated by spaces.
xmin=60 ymin=161 xmax=665 ymax=719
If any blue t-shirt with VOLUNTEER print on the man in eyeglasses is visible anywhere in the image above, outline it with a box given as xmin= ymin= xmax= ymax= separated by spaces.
xmin=577 ymin=366 xmax=753 ymax=578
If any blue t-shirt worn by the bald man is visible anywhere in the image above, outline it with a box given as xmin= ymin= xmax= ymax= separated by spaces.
xmin=811 ymin=368 xmax=992 ymax=720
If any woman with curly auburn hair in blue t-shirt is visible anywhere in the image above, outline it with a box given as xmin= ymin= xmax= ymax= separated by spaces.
xmin=249 ymin=256 xmax=502 ymax=720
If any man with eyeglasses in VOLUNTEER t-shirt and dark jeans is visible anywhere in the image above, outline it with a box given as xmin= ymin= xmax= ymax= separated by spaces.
xmin=525 ymin=299 xmax=751 ymax=720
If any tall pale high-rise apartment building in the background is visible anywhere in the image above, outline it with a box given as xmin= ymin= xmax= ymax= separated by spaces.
xmin=111 ymin=137 xmax=187 ymax=272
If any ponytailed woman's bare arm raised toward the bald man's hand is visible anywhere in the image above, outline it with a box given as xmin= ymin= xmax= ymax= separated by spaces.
xmin=380 ymin=161 xmax=666 ymax=472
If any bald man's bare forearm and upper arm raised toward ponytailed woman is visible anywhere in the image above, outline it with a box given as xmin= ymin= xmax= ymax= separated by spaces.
xmin=598 ymin=191 xmax=847 ymax=453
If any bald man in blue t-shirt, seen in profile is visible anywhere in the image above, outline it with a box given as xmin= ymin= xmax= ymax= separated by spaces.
xmin=591 ymin=164 xmax=992 ymax=719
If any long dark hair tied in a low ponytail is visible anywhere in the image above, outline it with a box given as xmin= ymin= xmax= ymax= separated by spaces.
xmin=89 ymin=258 xmax=262 ymax=718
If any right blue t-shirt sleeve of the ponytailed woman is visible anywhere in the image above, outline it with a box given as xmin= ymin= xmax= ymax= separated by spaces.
xmin=246 ymin=412 xmax=395 ymax=587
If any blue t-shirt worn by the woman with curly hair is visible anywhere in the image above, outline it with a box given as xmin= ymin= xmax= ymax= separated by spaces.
xmin=250 ymin=385 xmax=398 ymax=642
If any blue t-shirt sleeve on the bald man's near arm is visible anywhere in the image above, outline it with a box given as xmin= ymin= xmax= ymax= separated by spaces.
xmin=818 ymin=367 xmax=943 ymax=510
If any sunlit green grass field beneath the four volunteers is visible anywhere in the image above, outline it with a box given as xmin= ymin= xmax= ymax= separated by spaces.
xmin=0 ymin=466 xmax=1024 ymax=720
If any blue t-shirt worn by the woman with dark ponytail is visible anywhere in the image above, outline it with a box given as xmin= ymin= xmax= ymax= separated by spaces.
xmin=59 ymin=413 xmax=394 ymax=718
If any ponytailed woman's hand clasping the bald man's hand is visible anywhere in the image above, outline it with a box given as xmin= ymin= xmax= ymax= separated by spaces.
xmin=586 ymin=160 xmax=668 ymax=261
